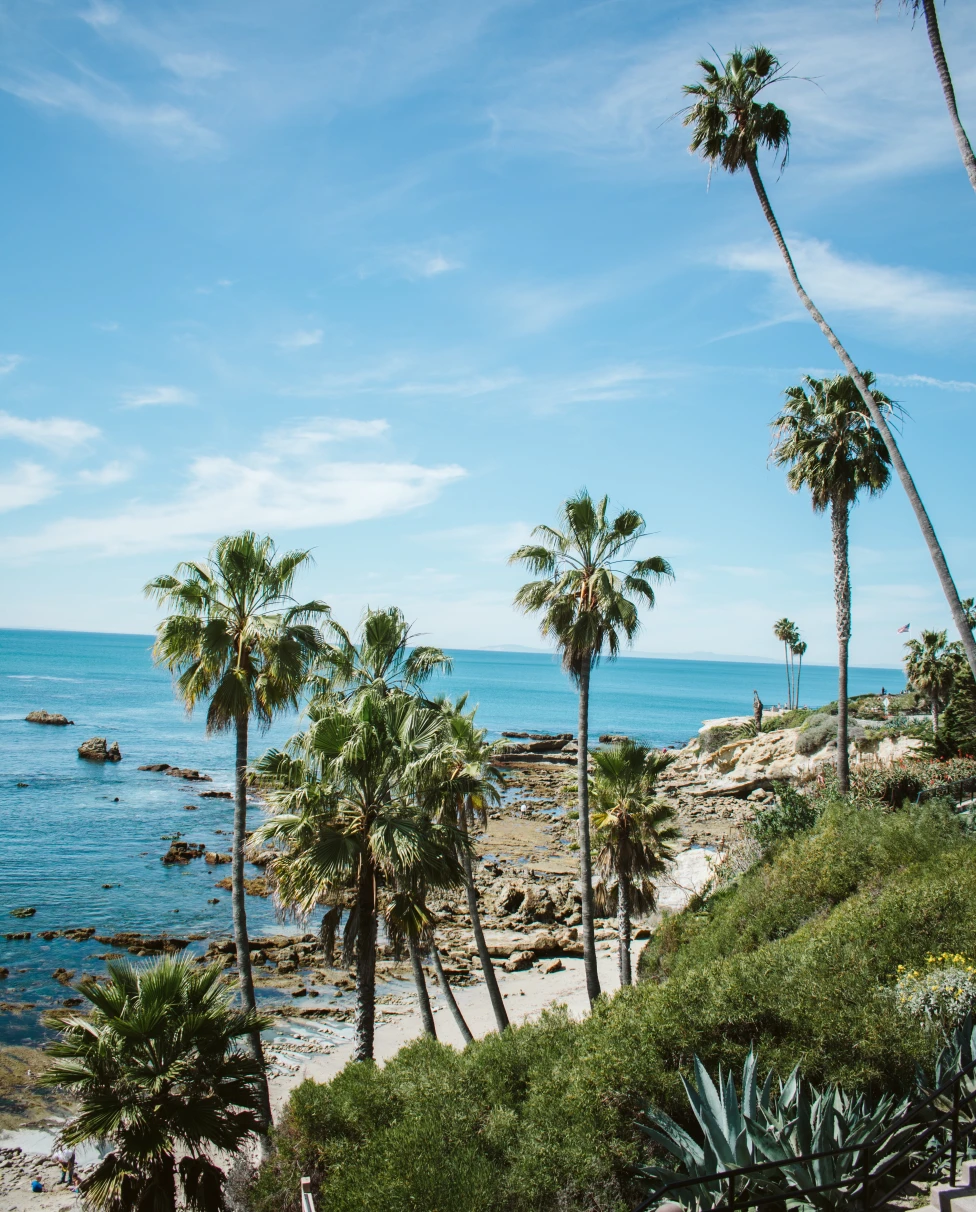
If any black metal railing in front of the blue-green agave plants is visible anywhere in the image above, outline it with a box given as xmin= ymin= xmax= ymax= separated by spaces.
xmin=634 ymin=1059 xmax=976 ymax=1212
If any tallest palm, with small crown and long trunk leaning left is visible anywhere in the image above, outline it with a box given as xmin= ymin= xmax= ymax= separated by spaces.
xmin=684 ymin=46 xmax=976 ymax=678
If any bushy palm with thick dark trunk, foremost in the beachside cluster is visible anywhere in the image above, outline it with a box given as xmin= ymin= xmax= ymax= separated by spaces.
xmin=255 ymin=687 xmax=464 ymax=1061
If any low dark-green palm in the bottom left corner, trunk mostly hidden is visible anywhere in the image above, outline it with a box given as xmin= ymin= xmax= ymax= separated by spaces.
xmin=41 ymin=956 xmax=270 ymax=1212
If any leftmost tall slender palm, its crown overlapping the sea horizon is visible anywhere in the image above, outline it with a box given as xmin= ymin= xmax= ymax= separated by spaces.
xmin=145 ymin=531 xmax=330 ymax=1125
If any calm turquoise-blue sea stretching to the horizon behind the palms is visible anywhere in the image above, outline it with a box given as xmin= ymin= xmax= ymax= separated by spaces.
xmin=0 ymin=630 xmax=903 ymax=1042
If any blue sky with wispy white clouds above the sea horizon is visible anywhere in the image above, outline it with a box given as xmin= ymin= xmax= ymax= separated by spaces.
xmin=0 ymin=0 xmax=976 ymax=665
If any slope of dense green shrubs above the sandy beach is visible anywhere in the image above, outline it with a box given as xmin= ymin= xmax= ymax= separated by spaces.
xmin=253 ymin=808 xmax=976 ymax=1212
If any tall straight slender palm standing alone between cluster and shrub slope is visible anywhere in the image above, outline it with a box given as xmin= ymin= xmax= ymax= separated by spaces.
xmin=509 ymin=488 xmax=673 ymax=1005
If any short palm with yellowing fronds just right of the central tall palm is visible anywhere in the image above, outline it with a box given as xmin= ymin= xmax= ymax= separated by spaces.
xmin=593 ymin=741 xmax=681 ymax=985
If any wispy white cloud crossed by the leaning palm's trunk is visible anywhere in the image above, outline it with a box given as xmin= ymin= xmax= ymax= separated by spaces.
xmin=717 ymin=239 xmax=976 ymax=325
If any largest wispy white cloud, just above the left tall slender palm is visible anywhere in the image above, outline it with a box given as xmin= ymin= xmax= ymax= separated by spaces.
xmin=0 ymin=422 xmax=466 ymax=559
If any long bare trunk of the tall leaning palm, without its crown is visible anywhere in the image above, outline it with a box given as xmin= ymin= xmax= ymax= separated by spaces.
xmin=749 ymin=159 xmax=976 ymax=678
